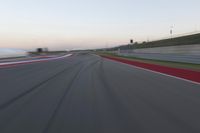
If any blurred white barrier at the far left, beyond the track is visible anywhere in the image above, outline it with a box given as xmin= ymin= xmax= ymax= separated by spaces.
xmin=0 ymin=48 xmax=28 ymax=58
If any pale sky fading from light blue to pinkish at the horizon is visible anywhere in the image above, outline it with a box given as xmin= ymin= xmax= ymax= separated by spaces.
xmin=0 ymin=0 xmax=200 ymax=50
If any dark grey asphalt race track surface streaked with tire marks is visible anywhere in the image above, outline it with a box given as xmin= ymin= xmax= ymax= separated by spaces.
xmin=0 ymin=54 xmax=200 ymax=133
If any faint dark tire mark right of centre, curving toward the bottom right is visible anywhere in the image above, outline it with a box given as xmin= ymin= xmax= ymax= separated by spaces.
xmin=95 ymin=59 xmax=145 ymax=133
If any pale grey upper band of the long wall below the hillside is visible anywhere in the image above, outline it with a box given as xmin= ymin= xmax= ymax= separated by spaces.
xmin=129 ymin=44 xmax=200 ymax=55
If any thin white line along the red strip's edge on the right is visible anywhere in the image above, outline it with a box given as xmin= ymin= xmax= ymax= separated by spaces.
xmin=104 ymin=59 xmax=200 ymax=85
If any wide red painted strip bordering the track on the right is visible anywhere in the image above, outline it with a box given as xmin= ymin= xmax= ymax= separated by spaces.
xmin=102 ymin=56 xmax=200 ymax=83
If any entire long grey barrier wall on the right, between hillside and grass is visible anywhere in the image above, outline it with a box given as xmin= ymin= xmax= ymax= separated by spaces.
xmin=114 ymin=44 xmax=200 ymax=64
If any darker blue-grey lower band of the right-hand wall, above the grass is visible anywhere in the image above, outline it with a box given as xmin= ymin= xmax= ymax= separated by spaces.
xmin=119 ymin=53 xmax=200 ymax=64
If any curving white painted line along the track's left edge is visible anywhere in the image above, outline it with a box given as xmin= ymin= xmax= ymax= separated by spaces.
xmin=0 ymin=54 xmax=72 ymax=66
